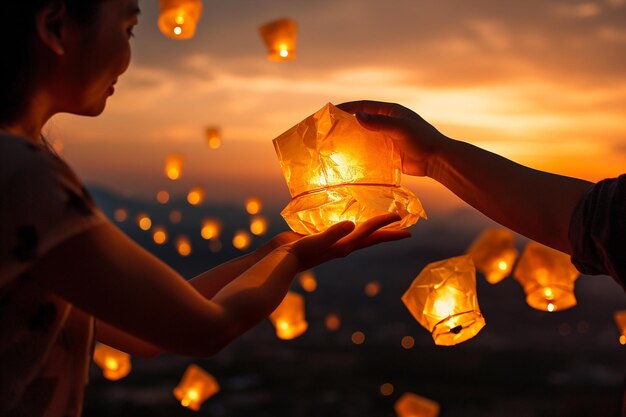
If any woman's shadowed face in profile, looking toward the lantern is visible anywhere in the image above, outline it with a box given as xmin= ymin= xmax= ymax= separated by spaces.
xmin=54 ymin=0 xmax=139 ymax=116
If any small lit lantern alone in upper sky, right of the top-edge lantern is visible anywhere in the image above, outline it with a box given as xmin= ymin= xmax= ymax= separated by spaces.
xmin=259 ymin=18 xmax=298 ymax=61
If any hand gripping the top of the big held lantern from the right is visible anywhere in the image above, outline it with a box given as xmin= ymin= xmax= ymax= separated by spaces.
xmin=337 ymin=100 xmax=448 ymax=176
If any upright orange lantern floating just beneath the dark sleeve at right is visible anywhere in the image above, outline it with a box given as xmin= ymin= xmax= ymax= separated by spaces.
xmin=513 ymin=242 xmax=579 ymax=312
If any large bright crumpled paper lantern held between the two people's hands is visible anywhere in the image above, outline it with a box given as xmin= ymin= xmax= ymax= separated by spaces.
xmin=273 ymin=103 xmax=426 ymax=234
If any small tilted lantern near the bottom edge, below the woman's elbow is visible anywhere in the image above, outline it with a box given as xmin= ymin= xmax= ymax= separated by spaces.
xmin=174 ymin=364 xmax=220 ymax=411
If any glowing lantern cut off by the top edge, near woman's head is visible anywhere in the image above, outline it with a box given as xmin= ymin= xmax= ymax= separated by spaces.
xmin=159 ymin=0 xmax=202 ymax=39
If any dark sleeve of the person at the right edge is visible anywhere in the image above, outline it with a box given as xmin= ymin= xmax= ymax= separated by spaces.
xmin=569 ymin=174 xmax=626 ymax=289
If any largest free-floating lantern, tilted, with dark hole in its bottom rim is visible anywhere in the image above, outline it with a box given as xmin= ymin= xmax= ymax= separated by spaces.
xmin=402 ymin=255 xmax=485 ymax=346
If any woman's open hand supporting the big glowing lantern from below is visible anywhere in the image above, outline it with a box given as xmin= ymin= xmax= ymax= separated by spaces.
xmin=278 ymin=213 xmax=411 ymax=271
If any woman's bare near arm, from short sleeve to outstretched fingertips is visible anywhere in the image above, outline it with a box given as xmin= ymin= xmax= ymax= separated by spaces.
xmin=30 ymin=216 xmax=408 ymax=356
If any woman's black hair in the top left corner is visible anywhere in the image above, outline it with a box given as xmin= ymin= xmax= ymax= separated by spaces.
xmin=0 ymin=0 xmax=104 ymax=126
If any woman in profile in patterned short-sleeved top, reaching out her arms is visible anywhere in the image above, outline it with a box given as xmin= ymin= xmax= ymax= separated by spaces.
xmin=0 ymin=0 xmax=409 ymax=416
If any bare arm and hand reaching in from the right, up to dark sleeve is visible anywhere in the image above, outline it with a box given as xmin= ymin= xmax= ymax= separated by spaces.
xmin=338 ymin=101 xmax=593 ymax=254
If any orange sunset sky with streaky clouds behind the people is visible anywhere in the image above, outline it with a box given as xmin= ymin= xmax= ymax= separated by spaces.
xmin=48 ymin=0 xmax=626 ymax=211
